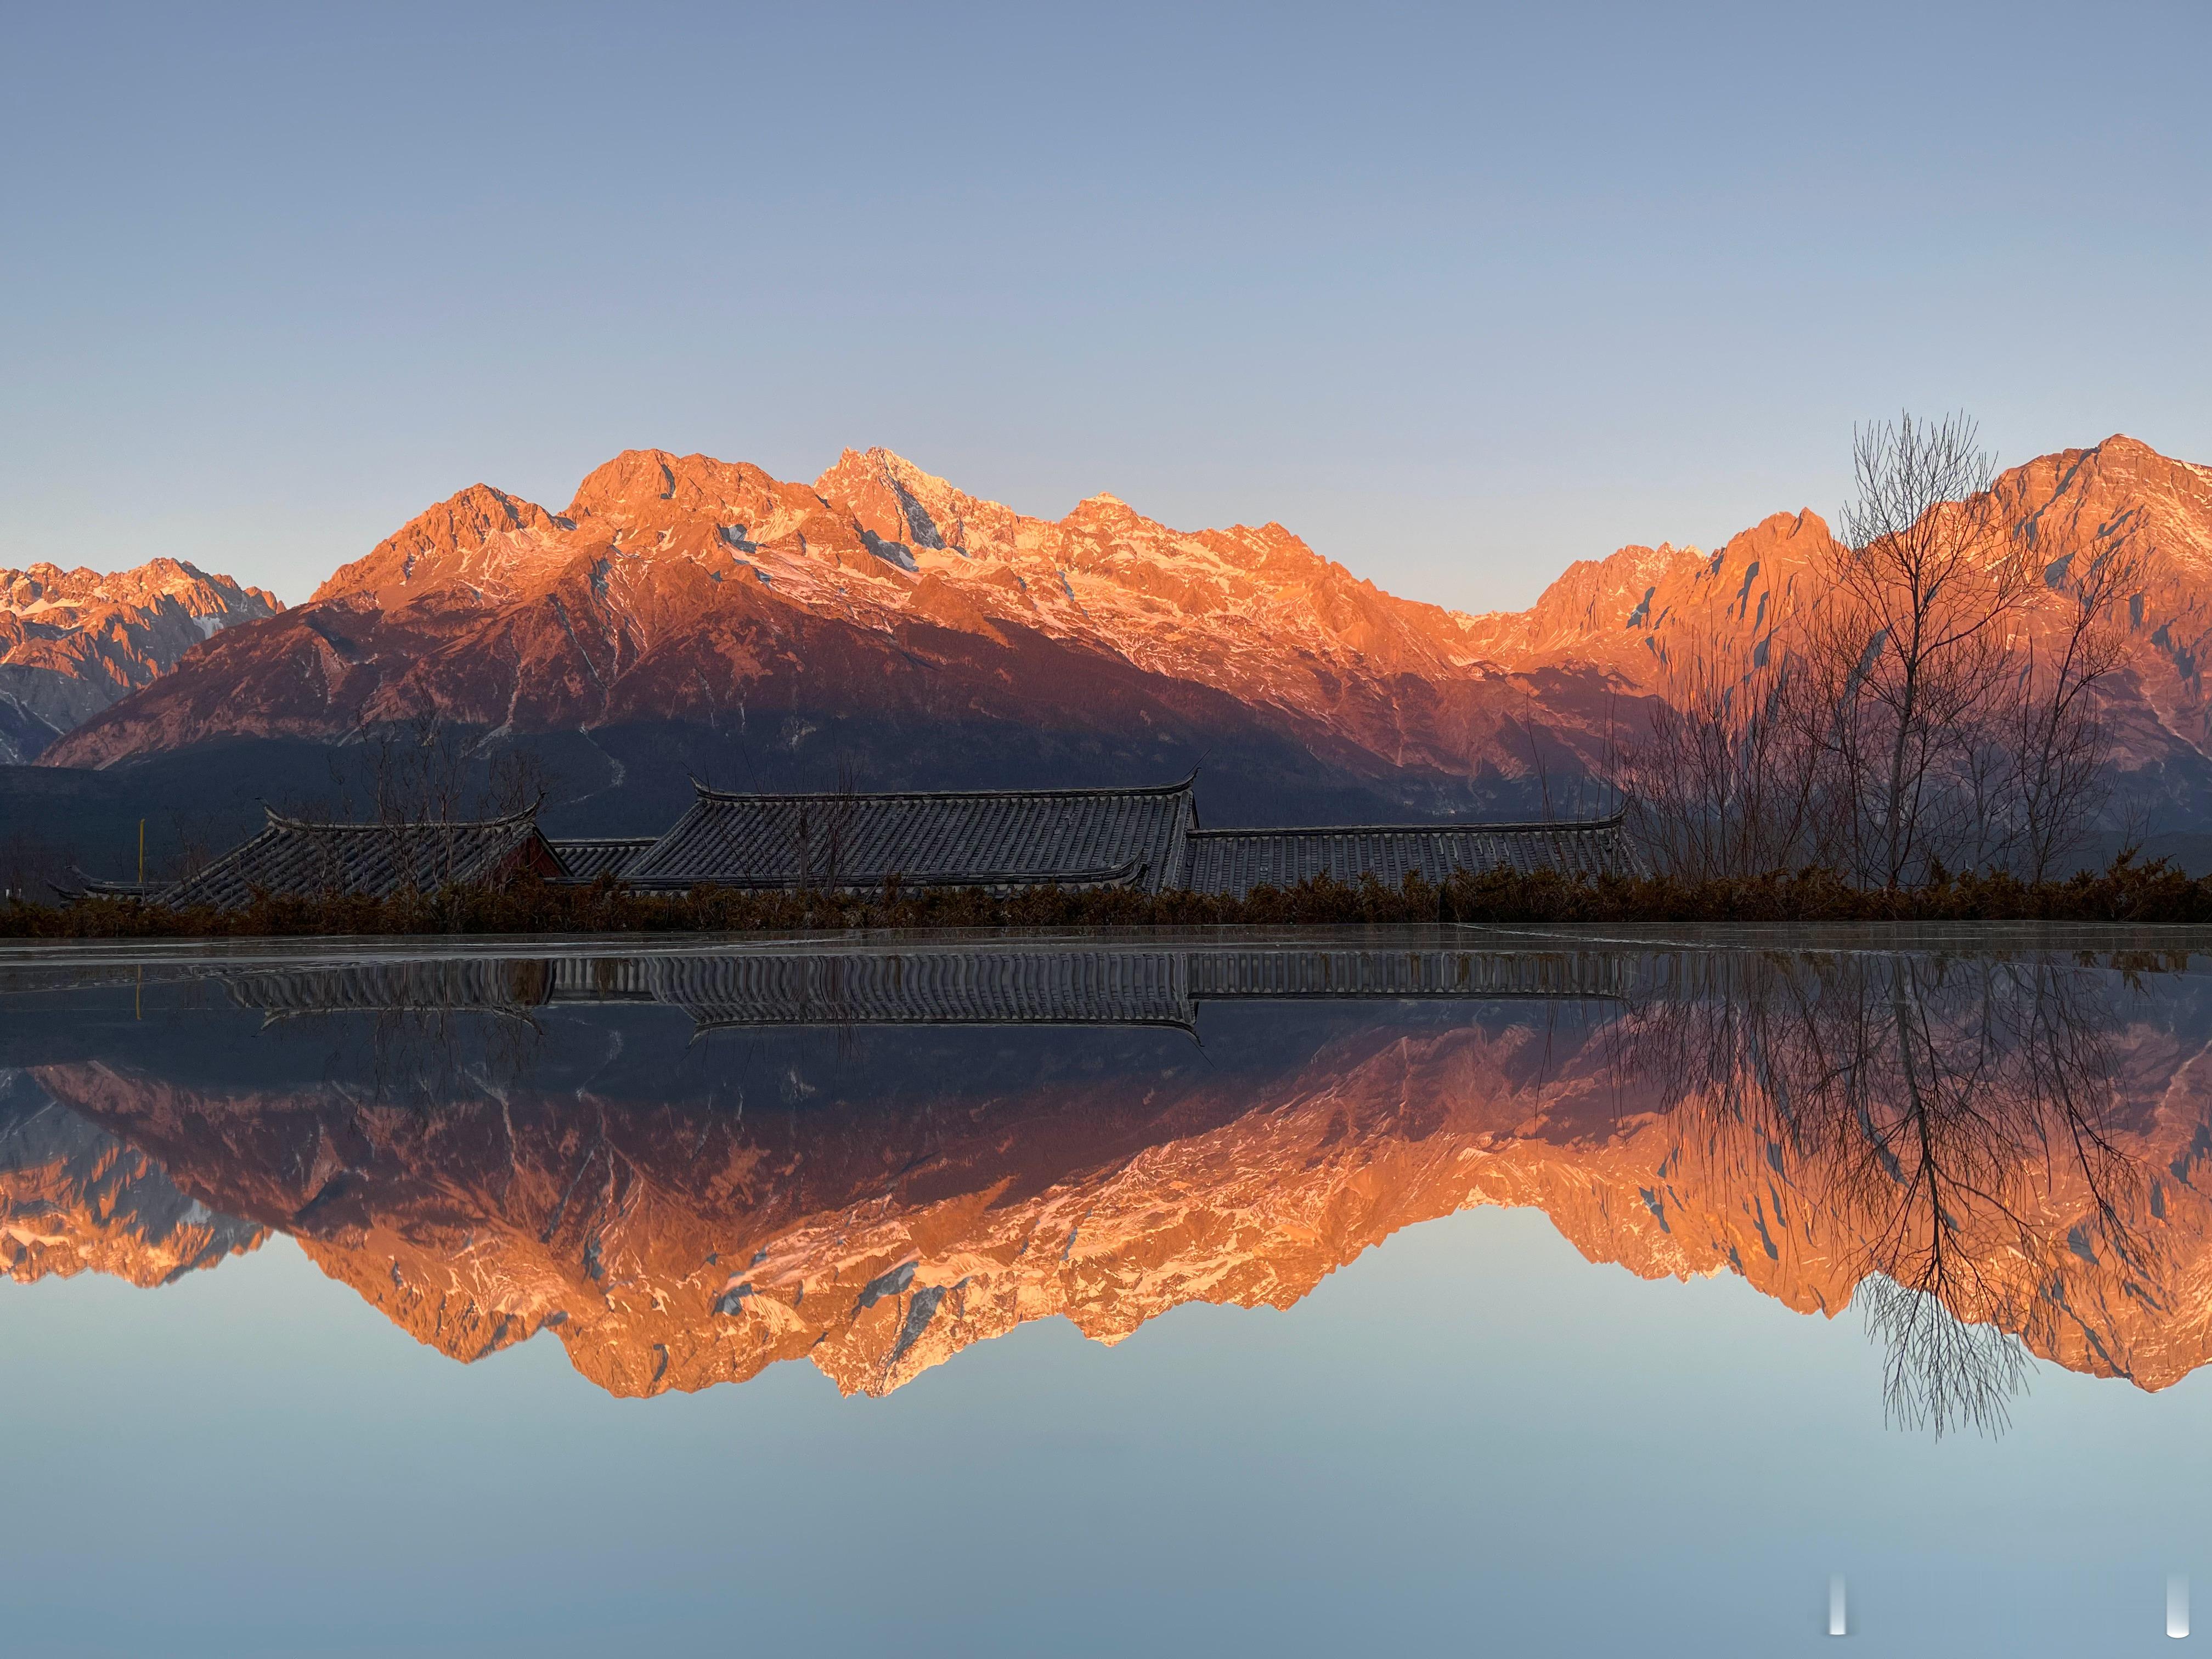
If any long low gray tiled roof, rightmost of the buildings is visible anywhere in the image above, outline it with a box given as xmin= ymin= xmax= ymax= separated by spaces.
xmin=1183 ymin=814 xmax=1635 ymax=894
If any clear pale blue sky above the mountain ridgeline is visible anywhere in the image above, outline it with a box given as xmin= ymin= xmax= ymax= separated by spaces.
xmin=0 ymin=4 xmax=2212 ymax=608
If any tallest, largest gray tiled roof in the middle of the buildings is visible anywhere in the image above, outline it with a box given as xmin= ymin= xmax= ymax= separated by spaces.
xmin=626 ymin=778 xmax=1197 ymax=889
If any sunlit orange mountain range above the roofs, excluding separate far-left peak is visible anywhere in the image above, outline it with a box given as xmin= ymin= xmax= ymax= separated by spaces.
xmin=26 ymin=438 xmax=2212 ymax=832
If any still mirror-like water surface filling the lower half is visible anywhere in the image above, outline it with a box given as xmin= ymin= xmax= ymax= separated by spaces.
xmin=0 ymin=929 xmax=2212 ymax=1655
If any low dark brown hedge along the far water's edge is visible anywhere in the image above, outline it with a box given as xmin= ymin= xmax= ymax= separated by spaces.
xmin=13 ymin=858 xmax=2212 ymax=938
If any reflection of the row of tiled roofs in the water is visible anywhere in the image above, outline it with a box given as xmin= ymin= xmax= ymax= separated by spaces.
xmin=211 ymin=945 xmax=1623 ymax=1031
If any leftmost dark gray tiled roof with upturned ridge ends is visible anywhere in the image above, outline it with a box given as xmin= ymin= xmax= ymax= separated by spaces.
xmin=157 ymin=808 xmax=557 ymax=909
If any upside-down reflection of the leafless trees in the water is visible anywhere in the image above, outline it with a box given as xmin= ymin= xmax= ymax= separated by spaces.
xmin=1619 ymin=953 xmax=2159 ymax=1436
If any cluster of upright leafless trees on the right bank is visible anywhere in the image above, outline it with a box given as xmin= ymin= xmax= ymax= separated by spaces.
xmin=1615 ymin=416 xmax=2146 ymax=887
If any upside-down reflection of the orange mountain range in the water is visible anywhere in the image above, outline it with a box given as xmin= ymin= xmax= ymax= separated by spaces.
xmin=13 ymin=934 xmax=2212 ymax=1423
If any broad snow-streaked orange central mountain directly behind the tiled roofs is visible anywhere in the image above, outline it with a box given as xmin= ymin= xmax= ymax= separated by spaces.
xmin=47 ymin=452 xmax=1597 ymax=814
